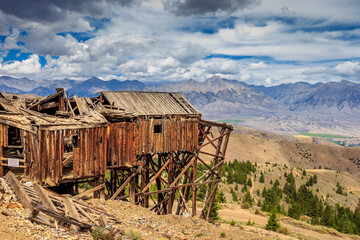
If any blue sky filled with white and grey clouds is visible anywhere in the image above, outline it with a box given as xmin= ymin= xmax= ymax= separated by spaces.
xmin=0 ymin=0 xmax=360 ymax=85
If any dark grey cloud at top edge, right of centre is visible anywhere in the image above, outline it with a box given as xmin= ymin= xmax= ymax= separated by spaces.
xmin=163 ymin=0 xmax=257 ymax=16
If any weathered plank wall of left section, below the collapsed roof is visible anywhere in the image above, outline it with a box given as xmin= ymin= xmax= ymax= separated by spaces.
xmin=26 ymin=127 xmax=107 ymax=185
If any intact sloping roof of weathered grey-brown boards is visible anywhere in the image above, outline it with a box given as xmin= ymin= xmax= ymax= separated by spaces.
xmin=101 ymin=91 xmax=200 ymax=115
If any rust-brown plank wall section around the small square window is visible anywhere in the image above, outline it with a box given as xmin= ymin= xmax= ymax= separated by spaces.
xmin=136 ymin=116 xmax=199 ymax=155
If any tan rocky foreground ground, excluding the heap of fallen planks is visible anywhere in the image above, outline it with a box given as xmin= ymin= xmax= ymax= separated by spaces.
xmin=0 ymin=183 xmax=277 ymax=240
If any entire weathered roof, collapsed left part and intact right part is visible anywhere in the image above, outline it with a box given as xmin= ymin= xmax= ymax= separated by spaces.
xmin=0 ymin=88 xmax=200 ymax=131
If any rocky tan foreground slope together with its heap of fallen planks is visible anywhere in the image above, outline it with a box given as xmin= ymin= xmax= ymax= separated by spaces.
xmin=0 ymin=172 xmax=264 ymax=240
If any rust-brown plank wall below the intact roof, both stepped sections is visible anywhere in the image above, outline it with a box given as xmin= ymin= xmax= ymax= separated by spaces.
xmin=108 ymin=116 xmax=199 ymax=167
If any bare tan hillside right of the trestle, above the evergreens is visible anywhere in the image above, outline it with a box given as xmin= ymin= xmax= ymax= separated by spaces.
xmin=214 ymin=125 xmax=360 ymax=173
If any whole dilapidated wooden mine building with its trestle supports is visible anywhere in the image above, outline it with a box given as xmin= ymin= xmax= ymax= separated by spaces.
xmin=0 ymin=88 xmax=232 ymax=219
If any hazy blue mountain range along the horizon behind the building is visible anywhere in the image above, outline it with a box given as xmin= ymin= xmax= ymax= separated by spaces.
xmin=0 ymin=76 xmax=360 ymax=135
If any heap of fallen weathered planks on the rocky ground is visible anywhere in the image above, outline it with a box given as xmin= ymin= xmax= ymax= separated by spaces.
xmin=2 ymin=172 xmax=119 ymax=230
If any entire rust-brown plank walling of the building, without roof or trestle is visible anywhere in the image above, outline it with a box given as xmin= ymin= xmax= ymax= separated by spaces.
xmin=0 ymin=116 xmax=199 ymax=185
